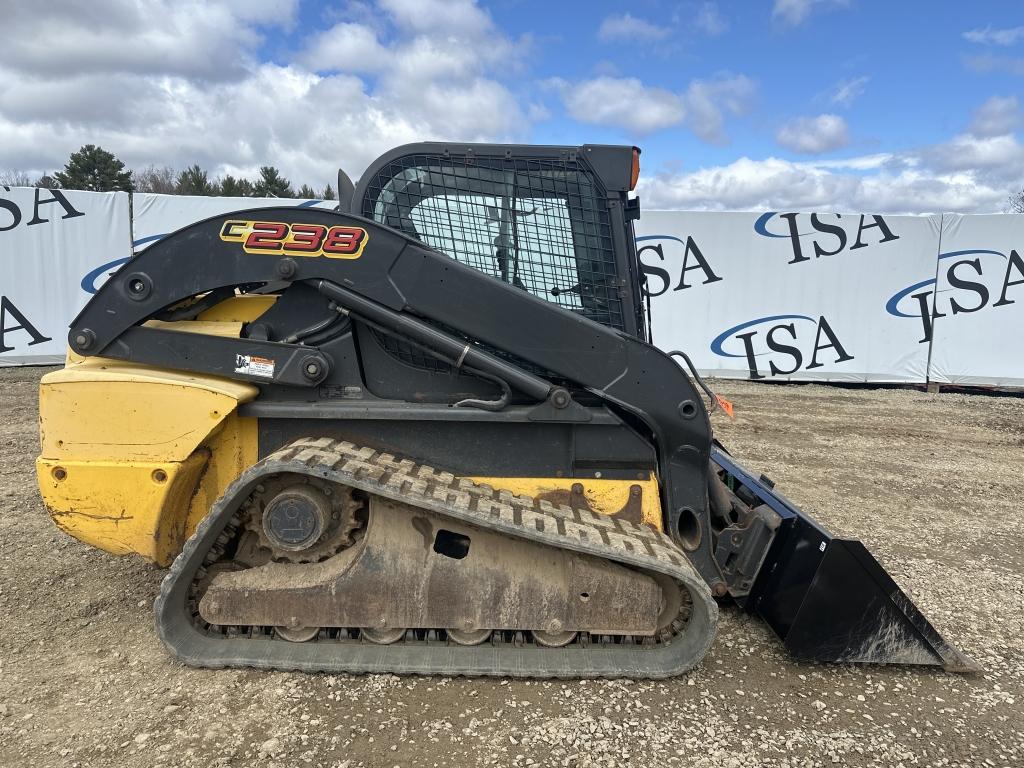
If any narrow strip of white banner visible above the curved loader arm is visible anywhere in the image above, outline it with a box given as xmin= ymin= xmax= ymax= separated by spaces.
xmin=132 ymin=193 xmax=338 ymax=253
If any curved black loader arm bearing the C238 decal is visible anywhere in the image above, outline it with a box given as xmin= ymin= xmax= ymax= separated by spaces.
xmin=69 ymin=208 xmax=724 ymax=594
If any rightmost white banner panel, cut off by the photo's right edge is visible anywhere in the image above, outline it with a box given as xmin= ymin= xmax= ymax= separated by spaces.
xmin=929 ymin=214 xmax=1024 ymax=387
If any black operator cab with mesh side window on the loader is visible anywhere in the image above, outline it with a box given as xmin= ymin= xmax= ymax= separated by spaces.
xmin=350 ymin=142 xmax=649 ymax=341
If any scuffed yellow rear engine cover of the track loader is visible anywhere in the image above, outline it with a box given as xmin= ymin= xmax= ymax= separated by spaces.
xmin=36 ymin=355 xmax=258 ymax=565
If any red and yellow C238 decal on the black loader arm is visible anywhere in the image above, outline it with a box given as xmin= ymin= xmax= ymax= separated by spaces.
xmin=220 ymin=219 xmax=370 ymax=259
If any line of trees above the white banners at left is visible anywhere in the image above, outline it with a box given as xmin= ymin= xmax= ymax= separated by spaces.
xmin=0 ymin=144 xmax=335 ymax=200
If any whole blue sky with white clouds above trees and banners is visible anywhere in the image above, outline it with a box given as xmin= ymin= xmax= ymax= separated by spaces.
xmin=0 ymin=0 xmax=1024 ymax=212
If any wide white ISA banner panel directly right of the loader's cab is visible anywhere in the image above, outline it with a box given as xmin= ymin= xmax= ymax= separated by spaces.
xmin=636 ymin=211 xmax=940 ymax=383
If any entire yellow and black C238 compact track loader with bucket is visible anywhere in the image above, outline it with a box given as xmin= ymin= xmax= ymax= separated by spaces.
xmin=38 ymin=143 xmax=974 ymax=678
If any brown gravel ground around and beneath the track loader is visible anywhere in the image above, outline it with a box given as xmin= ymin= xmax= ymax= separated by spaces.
xmin=0 ymin=369 xmax=1024 ymax=768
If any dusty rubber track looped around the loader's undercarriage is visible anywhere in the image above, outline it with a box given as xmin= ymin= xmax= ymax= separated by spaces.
xmin=155 ymin=438 xmax=718 ymax=678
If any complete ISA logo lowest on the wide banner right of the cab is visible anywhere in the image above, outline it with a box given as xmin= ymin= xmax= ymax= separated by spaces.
xmin=711 ymin=314 xmax=855 ymax=379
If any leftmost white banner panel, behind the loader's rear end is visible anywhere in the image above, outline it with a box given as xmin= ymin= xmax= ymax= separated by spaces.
xmin=0 ymin=186 xmax=131 ymax=366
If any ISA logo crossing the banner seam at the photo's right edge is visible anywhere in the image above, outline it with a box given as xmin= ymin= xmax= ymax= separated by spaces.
xmin=886 ymin=248 xmax=1024 ymax=344
